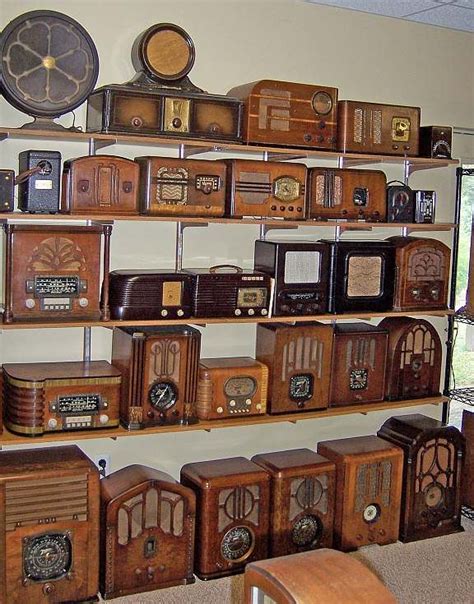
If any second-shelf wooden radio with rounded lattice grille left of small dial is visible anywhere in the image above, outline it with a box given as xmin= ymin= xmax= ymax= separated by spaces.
xmin=135 ymin=157 xmax=226 ymax=216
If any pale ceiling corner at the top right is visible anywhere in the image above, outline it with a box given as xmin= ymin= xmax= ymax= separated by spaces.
xmin=305 ymin=0 xmax=474 ymax=32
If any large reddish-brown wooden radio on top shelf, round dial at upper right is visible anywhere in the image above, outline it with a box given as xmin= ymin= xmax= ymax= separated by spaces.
xmin=228 ymin=80 xmax=338 ymax=150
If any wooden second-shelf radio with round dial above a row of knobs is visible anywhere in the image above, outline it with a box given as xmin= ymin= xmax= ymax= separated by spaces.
xmin=224 ymin=159 xmax=307 ymax=220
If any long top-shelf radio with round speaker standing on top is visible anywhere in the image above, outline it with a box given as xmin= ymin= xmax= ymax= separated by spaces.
xmin=87 ymin=23 xmax=243 ymax=142
